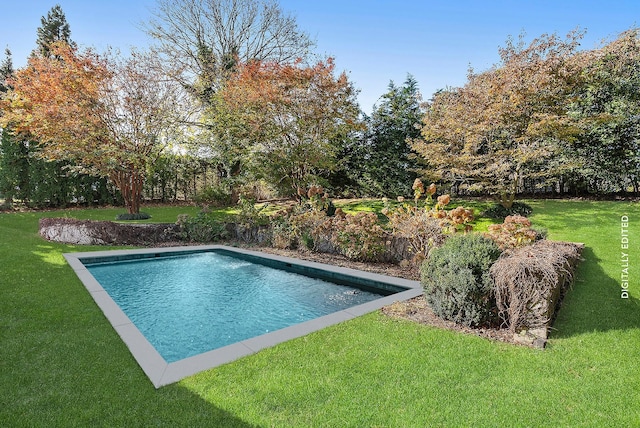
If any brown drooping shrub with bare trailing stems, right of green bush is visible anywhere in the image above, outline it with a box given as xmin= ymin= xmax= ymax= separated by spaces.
xmin=490 ymin=240 xmax=580 ymax=332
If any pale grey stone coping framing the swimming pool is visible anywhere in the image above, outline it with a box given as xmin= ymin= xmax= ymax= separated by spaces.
xmin=64 ymin=245 xmax=422 ymax=388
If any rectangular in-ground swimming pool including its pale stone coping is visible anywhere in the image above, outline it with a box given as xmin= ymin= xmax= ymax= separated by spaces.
xmin=65 ymin=245 xmax=422 ymax=387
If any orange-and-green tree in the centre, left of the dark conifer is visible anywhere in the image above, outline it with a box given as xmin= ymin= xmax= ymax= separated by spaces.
xmin=210 ymin=59 xmax=359 ymax=195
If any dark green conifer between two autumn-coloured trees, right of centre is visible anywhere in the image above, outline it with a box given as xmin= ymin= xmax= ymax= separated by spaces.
xmin=354 ymin=75 xmax=424 ymax=196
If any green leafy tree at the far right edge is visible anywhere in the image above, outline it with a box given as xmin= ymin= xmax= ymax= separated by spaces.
xmin=565 ymin=28 xmax=640 ymax=193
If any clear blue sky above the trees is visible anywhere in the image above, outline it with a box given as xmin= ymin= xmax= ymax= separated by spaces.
xmin=0 ymin=0 xmax=640 ymax=114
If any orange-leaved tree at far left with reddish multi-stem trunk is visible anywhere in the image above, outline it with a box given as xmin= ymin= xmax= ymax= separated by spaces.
xmin=3 ymin=43 xmax=182 ymax=213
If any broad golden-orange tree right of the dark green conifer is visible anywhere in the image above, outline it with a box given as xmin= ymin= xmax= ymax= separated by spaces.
xmin=412 ymin=32 xmax=581 ymax=207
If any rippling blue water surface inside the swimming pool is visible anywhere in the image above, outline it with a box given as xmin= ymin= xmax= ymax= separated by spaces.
xmin=87 ymin=252 xmax=381 ymax=363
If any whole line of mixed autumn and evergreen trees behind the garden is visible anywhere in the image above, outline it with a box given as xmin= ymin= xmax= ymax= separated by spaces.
xmin=0 ymin=0 xmax=640 ymax=213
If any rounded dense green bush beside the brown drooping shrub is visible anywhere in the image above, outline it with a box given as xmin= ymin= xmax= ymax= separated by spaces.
xmin=420 ymin=234 xmax=500 ymax=326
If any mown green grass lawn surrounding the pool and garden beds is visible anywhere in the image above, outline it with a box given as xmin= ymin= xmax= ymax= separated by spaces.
xmin=0 ymin=200 xmax=640 ymax=427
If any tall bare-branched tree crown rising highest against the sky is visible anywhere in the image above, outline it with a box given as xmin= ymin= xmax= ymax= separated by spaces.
xmin=145 ymin=0 xmax=314 ymax=104
